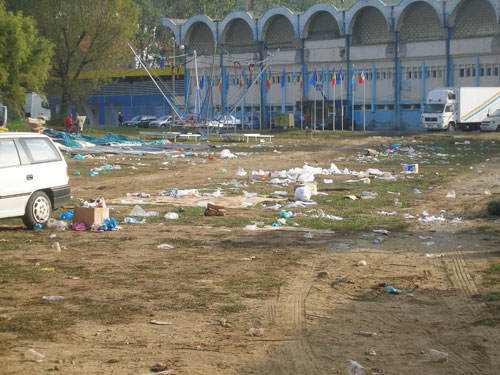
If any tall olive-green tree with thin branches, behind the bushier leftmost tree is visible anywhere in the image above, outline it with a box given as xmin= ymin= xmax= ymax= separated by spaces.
xmin=9 ymin=0 xmax=139 ymax=113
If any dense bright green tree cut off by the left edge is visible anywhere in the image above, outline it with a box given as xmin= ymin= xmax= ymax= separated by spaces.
xmin=0 ymin=2 xmax=53 ymax=116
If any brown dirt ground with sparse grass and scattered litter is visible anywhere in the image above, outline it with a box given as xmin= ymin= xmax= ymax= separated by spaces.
xmin=0 ymin=133 xmax=500 ymax=375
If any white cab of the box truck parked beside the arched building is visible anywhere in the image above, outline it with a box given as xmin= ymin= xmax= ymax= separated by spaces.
xmin=421 ymin=88 xmax=458 ymax=131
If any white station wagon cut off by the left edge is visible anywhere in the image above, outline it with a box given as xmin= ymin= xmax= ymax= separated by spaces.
xmin=0 ymin=132 xmax=70 ymax=229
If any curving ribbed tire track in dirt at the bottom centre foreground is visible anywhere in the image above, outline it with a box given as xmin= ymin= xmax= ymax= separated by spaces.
xmin=261 ymin=265 xmax=323 ymax=375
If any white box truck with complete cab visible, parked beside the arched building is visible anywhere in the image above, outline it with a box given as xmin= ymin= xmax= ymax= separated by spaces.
xmin=421 ymin=87 xmax=500 ymax=131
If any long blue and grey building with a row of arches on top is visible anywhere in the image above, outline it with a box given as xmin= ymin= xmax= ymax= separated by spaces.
xmin=157 ymin=0 xmax=500 ymax=130
